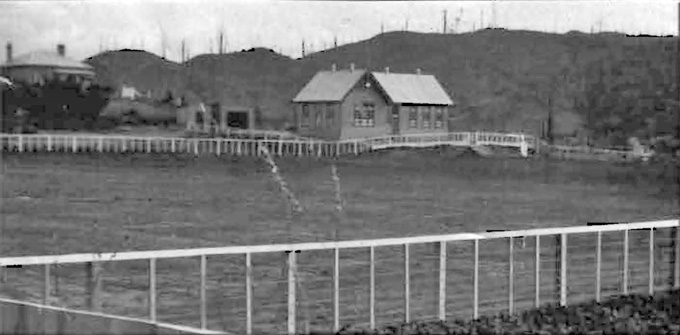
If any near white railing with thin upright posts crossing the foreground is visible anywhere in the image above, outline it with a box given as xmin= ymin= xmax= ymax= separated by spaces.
xmin=0 ymin=220 xmax=680 ymax=334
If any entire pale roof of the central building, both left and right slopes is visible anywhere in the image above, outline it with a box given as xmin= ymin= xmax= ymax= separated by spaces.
xmin=293 ymin=70 xmax=453 ymax=106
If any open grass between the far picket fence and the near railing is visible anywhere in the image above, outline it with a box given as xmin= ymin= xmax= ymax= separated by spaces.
xmin=0 ymin=151 xmax=677 ymax=256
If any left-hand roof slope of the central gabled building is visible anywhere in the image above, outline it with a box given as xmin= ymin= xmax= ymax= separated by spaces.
xmin=293 ymin=70 xmax=366 ymax=102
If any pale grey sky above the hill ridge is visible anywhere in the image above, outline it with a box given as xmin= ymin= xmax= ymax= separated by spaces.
xmin=0 ymin=0 xmax=678 ymax=63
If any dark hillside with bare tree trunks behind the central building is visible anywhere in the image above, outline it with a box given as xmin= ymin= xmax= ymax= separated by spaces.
xmin=87 ymin=29 xmax=675 ymax=142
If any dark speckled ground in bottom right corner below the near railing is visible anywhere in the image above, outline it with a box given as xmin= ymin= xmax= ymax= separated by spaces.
xmin=326 ymin=290 xmax=680 ymax=335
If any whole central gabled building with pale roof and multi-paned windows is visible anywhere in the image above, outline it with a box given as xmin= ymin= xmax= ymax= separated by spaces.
xmin=293 ymin=64 xmax=454 ymax=140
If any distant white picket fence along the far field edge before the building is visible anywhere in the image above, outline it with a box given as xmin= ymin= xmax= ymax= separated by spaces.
xmin=0 ymin=132 xmax=536 ymax=157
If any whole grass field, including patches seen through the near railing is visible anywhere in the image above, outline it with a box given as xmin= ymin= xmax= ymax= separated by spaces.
xmin=0 ymin=149 xmax=678 ymax=331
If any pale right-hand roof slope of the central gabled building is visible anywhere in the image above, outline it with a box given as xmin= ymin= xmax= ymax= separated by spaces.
xmin=371 ymin=72 xmax=453 ymax=106
